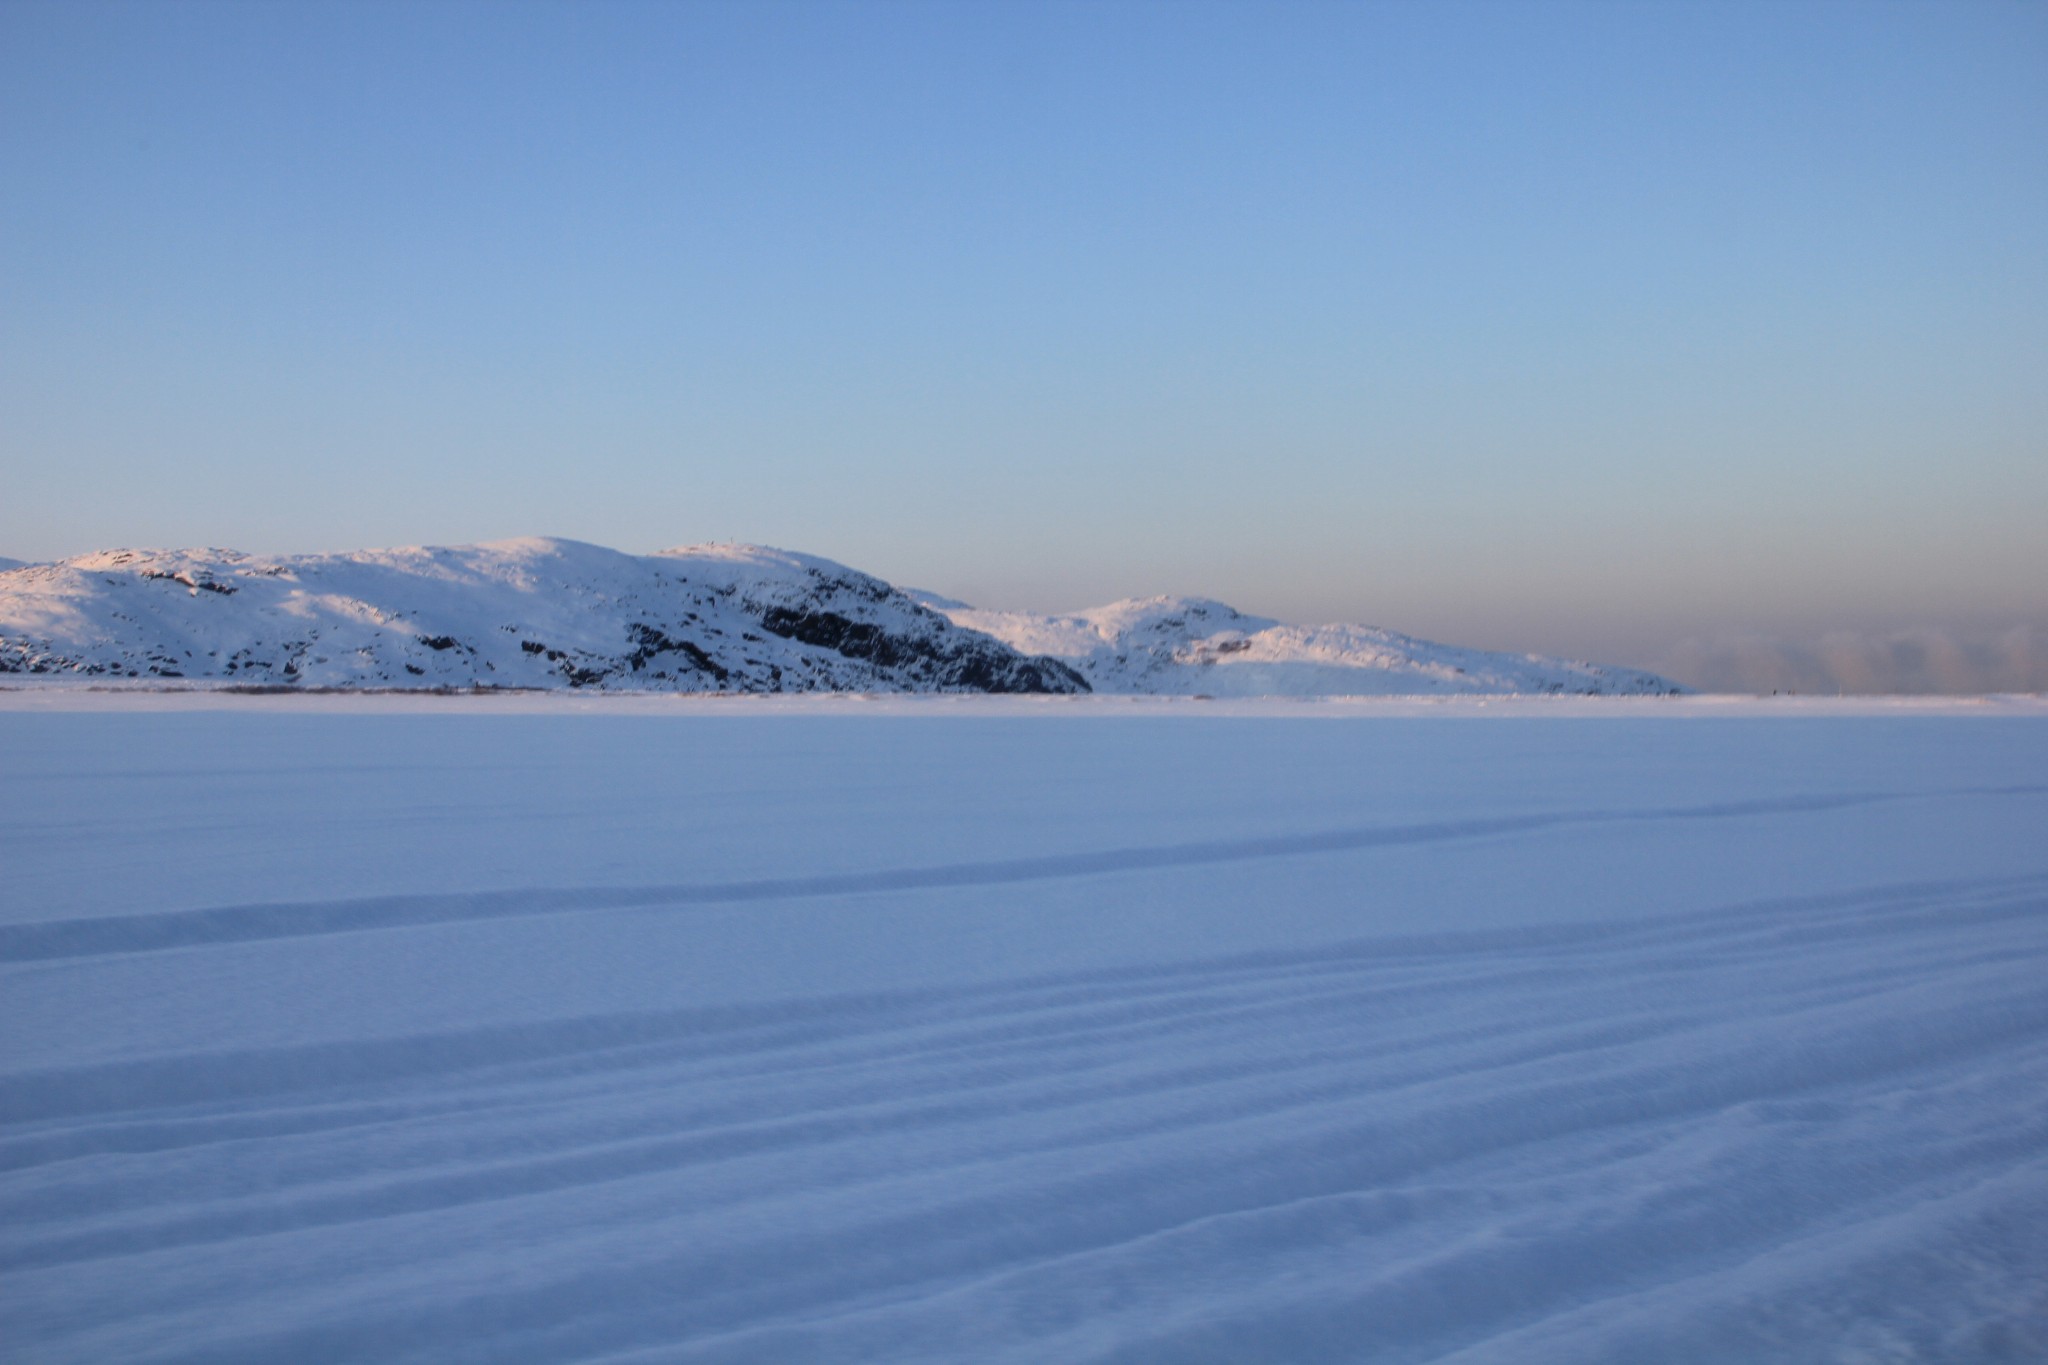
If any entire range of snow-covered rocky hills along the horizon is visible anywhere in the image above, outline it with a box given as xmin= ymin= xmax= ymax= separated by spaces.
xmin=0 ymin=536 xmax=1679 ymax=696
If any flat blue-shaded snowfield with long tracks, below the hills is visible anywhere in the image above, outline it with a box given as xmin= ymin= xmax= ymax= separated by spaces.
xmin=0 ymin=688 xmax=2048 ymax=1365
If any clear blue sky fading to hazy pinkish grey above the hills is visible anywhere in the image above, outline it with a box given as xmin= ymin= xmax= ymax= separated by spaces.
xmin=0 ymin=0 xmax=2048 ymax=675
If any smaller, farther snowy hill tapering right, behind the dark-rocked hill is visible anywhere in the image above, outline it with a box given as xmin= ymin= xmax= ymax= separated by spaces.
xmin=911 ymin=593 xmax=1681 ymax=696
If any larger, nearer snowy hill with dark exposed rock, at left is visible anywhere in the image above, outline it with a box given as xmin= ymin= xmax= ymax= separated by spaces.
xmin=0 ymin=538 xmax=1087 ymax=692
